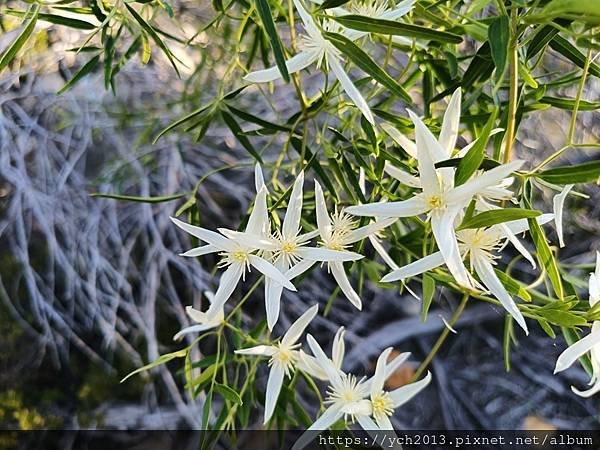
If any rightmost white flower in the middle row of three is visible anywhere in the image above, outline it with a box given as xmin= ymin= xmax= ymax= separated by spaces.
xmin=315 ymin=180 xmax=396 ymax=309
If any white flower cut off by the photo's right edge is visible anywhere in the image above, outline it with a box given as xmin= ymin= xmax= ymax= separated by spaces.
xmin=554 ymin=252 xmax=600 ymax=397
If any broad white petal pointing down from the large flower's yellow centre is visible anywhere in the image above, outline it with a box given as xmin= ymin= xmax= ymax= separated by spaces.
xmin=431 ymin=208 xmax=475 ymax=289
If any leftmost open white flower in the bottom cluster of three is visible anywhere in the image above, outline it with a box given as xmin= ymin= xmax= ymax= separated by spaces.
xmin=235 ymin=305 xmax=319 ymax=423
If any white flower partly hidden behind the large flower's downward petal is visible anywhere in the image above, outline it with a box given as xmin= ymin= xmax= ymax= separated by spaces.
xmin=381 ymin=214 xmax=554 ymax=334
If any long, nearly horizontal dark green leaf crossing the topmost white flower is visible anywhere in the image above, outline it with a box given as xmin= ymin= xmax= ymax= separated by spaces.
xmin=330 ymin=14 xmax=462 ymax=44
